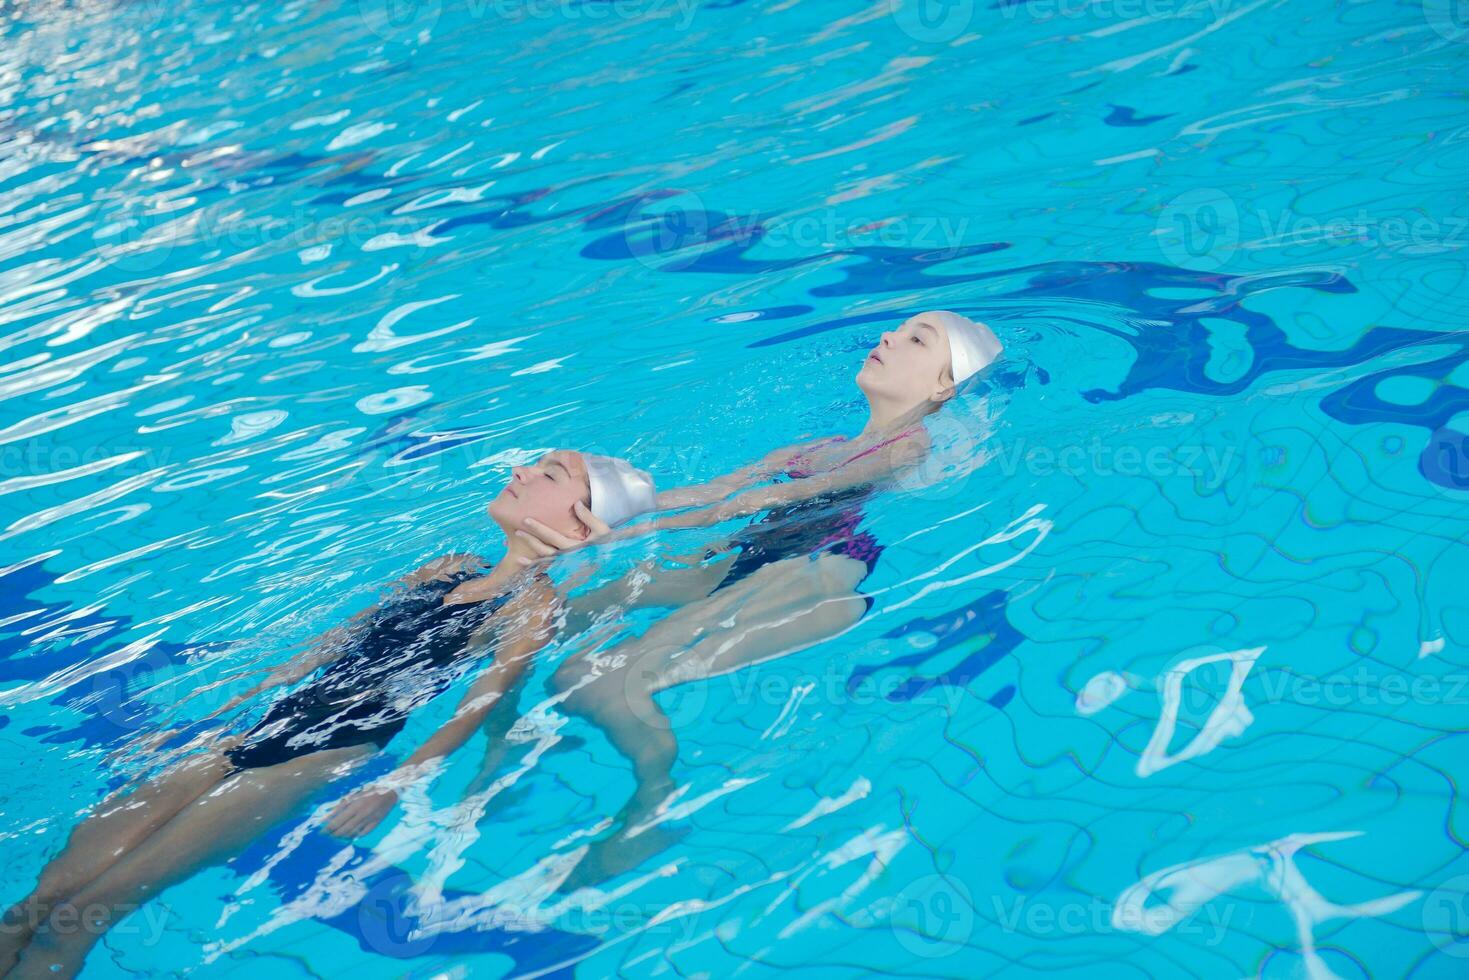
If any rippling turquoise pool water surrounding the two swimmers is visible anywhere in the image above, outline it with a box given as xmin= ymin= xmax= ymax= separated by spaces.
xmin=0 ymin=0 xmax=1469 ymax=979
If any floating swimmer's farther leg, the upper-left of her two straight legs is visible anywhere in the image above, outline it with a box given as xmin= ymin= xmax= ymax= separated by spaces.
xmin=0 ymin=754 xmax=231 ymax=974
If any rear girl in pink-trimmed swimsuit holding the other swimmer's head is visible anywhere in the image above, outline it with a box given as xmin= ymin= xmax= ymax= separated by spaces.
xmin=514 ymin=311 xmax=1000 ymax=889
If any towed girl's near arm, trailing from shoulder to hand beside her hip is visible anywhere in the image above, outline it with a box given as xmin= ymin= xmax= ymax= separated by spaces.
xmin=326 ymin=588 xmax=555 ymax=837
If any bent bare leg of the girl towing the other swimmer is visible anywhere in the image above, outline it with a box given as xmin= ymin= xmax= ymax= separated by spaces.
xmin=552 ymin=555 xmax=867 ymax=887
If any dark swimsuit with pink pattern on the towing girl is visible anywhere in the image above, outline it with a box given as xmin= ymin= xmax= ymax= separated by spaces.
xmin=714 ymin=429 xmax=912 ymax=607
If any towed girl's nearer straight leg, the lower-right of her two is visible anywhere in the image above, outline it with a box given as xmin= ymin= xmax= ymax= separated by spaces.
xmin=10 ymin=746 xmax=372 ymax=979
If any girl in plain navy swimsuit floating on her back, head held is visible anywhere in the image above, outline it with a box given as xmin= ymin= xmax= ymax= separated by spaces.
xmin=0 ymin=451 xmax=655 ymax=977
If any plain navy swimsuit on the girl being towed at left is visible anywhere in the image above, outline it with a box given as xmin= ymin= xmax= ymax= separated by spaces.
xmin=225 ymin=570 xmax=510 ymax=768
